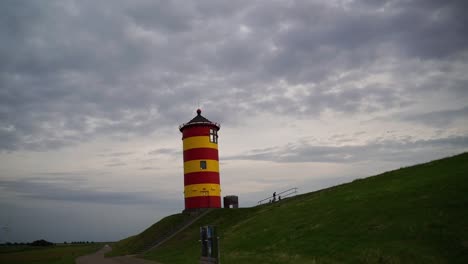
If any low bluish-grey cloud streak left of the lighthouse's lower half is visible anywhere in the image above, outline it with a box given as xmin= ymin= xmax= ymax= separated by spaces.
xmin=0 ymin=178 xmax=171 ymax=205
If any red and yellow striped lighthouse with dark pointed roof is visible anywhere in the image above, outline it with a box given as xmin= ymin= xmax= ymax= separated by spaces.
xmin=179 ymin=109 xmax=221 ymax=210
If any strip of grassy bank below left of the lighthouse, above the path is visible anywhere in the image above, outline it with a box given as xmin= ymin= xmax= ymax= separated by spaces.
xmin=106 ymin=214 xmax=190 ymax=256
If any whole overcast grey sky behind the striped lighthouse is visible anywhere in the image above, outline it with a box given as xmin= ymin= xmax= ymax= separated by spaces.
xmin=0 ymin=0 xmax=468 ymax=242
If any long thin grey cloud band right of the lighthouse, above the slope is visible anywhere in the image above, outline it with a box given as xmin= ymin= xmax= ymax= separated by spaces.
xmin=223 ymin=136 xmax=468 ymax=163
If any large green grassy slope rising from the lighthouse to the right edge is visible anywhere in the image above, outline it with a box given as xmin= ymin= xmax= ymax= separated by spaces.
xmin=111 ymin=153 xmax=468 ymax=264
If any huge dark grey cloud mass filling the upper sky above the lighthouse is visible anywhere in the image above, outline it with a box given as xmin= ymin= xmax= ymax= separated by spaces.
xmin=0 ymin=1 xmax=468 ymax=151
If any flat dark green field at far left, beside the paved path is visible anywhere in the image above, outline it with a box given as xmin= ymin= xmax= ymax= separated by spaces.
xmin=0 ymin=243 xmax=103 ymax=264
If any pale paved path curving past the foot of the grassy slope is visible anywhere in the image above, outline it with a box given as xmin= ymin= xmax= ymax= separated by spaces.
xmin=75 ymin=245 xmax=158 ymax=264
